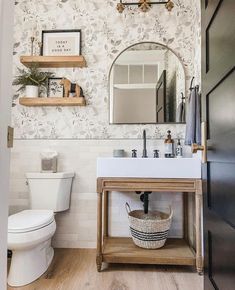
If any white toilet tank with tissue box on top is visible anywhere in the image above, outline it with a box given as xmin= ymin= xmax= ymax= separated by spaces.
xmin=26 ymin=172 xmax=74 ymax=212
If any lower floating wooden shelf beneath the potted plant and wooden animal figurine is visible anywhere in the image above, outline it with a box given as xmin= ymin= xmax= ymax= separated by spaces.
xmin=19 ymin=97 xmax=86 ymax=107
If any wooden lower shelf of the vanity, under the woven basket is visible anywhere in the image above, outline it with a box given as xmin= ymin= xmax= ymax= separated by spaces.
xmin=103 ymin=237 xmax=196 ymax=266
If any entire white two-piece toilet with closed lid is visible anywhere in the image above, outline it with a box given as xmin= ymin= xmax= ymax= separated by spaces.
xmin=8 ymin=172 xmax=74 ymax=287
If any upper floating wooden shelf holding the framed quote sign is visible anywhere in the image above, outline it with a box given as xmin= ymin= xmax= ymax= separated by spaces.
xmin=20 ymin=55 xmax=86 ymax=68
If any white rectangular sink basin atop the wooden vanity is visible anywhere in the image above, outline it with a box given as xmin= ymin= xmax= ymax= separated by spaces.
xmin=97 ymin=158 xmax=201 ymax=178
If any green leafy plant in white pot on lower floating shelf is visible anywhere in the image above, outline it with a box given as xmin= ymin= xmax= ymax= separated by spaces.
xmin=13 ymin=64 xmax=54 ymax=98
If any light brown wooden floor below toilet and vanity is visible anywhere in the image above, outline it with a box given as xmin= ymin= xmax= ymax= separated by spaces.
xmin=8 ymin=249 xmax=203 ymax=290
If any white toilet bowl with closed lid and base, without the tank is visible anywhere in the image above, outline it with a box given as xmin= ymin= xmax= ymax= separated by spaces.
xmin=8 ymin=210 xmax=56 ymax=287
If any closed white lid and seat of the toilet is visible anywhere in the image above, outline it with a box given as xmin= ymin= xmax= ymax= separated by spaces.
xmin=8 ymin=210 xmax=54 ymax=233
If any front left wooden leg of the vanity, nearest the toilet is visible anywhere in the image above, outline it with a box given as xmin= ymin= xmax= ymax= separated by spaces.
xmin=96 ymin=192 xmax=102 ymax=272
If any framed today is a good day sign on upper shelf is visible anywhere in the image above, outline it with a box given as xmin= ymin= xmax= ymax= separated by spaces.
xmin=41 ymin=29 xmax=82 ymax=56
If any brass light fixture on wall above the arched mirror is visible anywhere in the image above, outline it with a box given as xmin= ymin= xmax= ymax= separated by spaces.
xmin=117 ymin=0 xmax=174 ymax=13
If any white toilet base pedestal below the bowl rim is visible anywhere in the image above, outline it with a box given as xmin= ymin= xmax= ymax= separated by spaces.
xmin=8 ymin=239 xmax=54 ymax=287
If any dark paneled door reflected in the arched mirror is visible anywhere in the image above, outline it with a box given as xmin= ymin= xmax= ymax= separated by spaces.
xmin=156 ymin=70 xmax=166 ymax=123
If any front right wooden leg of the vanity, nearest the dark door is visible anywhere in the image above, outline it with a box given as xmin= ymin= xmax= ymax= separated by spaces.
xmin=195 ymin=180 xmax=203 ymax=274
